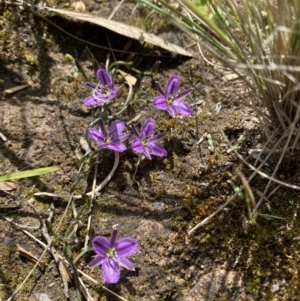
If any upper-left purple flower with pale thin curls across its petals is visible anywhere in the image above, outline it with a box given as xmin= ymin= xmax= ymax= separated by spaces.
xmin=83 ymin=68 xmax=118 ymax=107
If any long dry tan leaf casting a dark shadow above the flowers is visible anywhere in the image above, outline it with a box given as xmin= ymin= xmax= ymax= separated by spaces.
xmin=46 ymin=7 xmax=193 ymax=57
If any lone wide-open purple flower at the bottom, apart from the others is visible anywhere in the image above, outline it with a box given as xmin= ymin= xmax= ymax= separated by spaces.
xmin=88 ymin=229 xmax=139 ymax=283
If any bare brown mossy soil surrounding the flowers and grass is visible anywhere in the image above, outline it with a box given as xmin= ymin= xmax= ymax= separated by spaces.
xmin=0 ymin=0 xmax=300 ymax=301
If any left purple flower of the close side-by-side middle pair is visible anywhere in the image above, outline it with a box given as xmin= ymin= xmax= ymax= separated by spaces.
xmin=87 ymin=120 xmax=130 ymax=153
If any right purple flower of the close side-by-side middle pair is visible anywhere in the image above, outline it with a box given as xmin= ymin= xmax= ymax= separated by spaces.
xmin=131 ymin=118 xmax=167 ymax=160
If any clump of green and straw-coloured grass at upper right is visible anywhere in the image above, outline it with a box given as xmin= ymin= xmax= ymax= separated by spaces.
xmin=140 ymin=0 xmax=300 ymax=148
